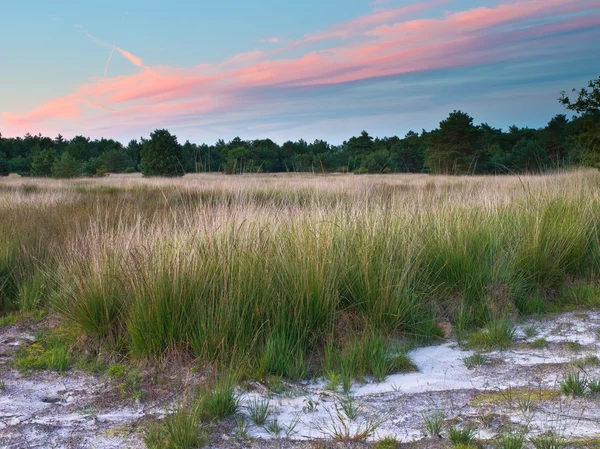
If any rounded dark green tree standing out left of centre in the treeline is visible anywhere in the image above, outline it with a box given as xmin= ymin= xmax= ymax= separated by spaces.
xmin=140 ymin=129 xmax=184 ymax=176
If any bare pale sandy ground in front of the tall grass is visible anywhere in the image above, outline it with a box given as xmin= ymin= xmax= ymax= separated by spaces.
xmin=0 ymin=311 xmax=600 ymax=449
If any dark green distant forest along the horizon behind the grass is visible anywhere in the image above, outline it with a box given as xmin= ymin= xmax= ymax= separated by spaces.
xmin=0 ymin=77 xmax=600 ymax=178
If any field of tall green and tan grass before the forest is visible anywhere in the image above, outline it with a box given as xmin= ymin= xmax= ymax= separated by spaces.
xmin=0 ymin=170 xmax=600 ymax=447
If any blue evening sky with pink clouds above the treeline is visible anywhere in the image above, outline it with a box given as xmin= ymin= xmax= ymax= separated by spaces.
xmin=0 ymin=0 xmax=600 ymax=143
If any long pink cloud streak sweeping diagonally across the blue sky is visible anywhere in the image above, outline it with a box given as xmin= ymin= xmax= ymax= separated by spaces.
xmin=2 ymin=0 xmax=600 ymax=133
